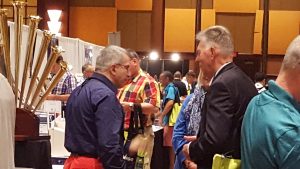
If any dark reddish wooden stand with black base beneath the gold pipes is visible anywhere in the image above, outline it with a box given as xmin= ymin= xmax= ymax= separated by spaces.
xmin=15 ymin=108 xmax=52 ymax=169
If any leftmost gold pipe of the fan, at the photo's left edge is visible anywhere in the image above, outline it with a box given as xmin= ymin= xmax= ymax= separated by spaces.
xmin=0 ymin=9 xmax=13 ymax=86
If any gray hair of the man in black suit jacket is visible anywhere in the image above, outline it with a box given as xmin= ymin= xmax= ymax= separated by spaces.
xmin=196 ymin=25 xmax=234 ymax=55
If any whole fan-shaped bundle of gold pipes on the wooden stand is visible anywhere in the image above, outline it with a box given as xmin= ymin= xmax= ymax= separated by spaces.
xmin=0 ymin=1 xmax=67 ymax=113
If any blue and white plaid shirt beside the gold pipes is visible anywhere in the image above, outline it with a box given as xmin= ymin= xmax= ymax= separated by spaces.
xmin=51 ymin=71 xmax=76 ymax=98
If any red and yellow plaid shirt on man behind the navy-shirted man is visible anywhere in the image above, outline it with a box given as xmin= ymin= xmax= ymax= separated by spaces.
xmin=118 ymin=70 xmax=160 ymax=129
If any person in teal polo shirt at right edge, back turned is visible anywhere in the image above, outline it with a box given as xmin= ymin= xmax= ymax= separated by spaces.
xmin=241 ymin=36 xmax=300 ymax=169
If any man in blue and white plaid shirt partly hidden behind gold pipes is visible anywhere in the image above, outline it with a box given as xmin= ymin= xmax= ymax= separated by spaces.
xmin=47 ymin=56 xmax=76 ymax=111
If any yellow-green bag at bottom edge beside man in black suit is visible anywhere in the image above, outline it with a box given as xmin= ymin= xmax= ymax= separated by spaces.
xmin=212 ymin=154 xmax=241 ymax=169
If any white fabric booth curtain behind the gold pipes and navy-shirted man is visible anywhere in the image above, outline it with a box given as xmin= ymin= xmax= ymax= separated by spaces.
xmin=8 ymin=21 xmax=104 ymax=76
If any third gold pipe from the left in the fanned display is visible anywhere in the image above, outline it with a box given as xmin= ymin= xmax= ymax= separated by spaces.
xmin=19 ymin=16 xmax=42 ymax=107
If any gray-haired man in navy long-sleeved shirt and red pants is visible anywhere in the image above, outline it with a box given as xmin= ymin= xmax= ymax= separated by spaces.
xmin=64 ymin=46 xmax=131 ymax=169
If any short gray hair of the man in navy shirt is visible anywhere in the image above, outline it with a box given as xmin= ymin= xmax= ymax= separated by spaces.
xmin=96 ymin=45 xmax=127 ymax=71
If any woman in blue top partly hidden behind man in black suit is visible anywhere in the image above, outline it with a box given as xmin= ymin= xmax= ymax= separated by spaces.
xmin=172 ymin=73 xmax=210 ymax=169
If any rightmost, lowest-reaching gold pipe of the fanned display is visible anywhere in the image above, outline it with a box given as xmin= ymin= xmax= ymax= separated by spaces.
xmin=33 ymin=61 xmax=68 ymax=113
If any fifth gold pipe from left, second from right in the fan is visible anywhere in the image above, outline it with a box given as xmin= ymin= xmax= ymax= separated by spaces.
xmin=29 ymin=46 xmax=63 ymax=107
